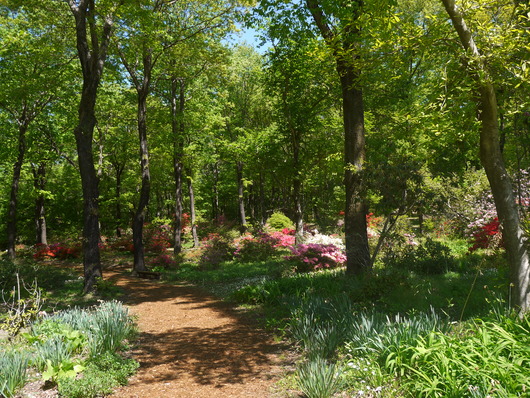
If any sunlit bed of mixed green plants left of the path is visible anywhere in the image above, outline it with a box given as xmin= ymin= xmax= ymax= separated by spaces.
xmin=0 ymin=301 xmax=138 ymax=398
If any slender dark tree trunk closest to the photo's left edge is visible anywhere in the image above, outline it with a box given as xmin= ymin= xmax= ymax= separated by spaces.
xmin=7 ymin=121 xmax=28 ymax=259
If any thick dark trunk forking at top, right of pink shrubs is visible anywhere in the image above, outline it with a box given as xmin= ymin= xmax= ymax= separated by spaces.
xmin=306 ymin=0 xmax=372 ymax=275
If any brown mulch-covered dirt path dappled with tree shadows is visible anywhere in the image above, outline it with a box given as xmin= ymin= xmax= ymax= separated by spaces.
xmin=106 ymin=272 xmax=281 ymax=398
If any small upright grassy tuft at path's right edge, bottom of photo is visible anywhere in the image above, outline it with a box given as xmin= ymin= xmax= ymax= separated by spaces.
xmin=296 ymin=358 xmax=341 ymax=398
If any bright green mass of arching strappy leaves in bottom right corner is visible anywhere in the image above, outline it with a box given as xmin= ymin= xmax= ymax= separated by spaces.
xmin=385 ymin=316 xmax=530 ymax=397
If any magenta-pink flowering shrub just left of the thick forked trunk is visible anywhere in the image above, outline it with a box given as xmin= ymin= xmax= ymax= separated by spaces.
xmin=286 ymin=243 xmax=346 ymax=272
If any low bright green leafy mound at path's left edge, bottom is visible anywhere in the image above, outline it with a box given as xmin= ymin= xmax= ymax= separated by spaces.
xmin=58 ymin=352 xmax=139 ymax=398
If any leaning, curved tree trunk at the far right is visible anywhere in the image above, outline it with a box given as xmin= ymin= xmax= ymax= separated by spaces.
xmin=442 ymin=0 xmax=530 ymax=314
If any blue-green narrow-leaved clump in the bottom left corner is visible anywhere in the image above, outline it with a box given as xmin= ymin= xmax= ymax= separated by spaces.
xmin=0 ymin=349 xmax=29 ymax=398
